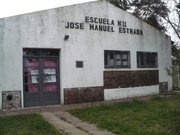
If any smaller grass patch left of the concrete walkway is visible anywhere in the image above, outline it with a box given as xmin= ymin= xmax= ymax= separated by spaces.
xmin=0 ymin=114 xmax=66 ymax=135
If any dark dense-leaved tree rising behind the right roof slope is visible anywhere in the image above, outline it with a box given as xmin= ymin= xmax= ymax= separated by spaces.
xmin=107 ymin=0 xmax=168 ymax=30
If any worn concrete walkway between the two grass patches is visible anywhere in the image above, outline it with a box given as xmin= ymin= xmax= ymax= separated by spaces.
xmin=42 ymin=111 xmax=115 ymax=135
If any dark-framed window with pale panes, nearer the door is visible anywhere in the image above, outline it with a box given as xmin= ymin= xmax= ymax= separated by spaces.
xmin=104 ymin=50 xmax=130 ymax=68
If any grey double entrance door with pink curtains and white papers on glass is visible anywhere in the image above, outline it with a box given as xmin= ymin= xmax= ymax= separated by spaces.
xmin=23 ymin=49 xmax=60 ymax=107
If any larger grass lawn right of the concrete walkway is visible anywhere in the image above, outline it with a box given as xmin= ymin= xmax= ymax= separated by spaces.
xmin=68 ymin=95 xmax=180 ymax=135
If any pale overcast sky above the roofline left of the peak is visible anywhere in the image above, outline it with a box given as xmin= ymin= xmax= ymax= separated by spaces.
xmin=0 ymin=0 xmax=96 ymax=18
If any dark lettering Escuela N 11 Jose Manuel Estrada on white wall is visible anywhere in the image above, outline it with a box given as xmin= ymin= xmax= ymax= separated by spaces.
xmin=65 ymin=16 xmax=143 ymax=35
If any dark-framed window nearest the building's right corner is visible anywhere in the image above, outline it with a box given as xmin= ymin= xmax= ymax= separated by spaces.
xmin=137 ymin=52 xmax=157 ymax=68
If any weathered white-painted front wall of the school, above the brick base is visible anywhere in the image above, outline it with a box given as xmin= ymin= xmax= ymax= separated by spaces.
xmin=0 ymin=1 xmax=171 ymax=107
